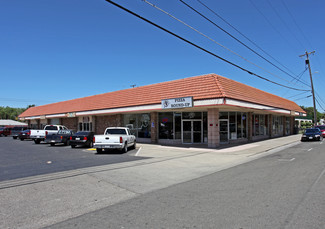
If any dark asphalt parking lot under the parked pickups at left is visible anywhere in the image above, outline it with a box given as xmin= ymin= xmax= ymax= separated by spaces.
xmin=0 ymin=137 xmax=144 ymax=181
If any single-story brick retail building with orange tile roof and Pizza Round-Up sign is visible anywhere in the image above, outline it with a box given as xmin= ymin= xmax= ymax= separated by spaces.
xmin=19 ymin=74 xmax=306 ymax=147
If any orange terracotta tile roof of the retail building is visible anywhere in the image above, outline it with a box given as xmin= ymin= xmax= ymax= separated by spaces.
xmin=19 ymin=74 xmax=304 ymax=117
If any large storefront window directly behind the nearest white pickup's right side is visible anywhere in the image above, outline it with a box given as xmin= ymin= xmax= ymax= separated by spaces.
xmin=124 ymin=113 xmax=151 ymax=138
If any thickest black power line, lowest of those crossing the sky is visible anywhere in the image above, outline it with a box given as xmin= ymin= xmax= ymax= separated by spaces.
xmin=106 ymin=0 xmax=309 ymax=91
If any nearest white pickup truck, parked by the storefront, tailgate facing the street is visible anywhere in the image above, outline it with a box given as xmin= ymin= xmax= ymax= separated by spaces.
xmin=93 ymin=127 xmax=136 ymax=153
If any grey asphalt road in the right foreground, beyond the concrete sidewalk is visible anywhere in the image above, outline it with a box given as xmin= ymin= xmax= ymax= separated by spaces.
xmin=49 ymin=142 xmax=325 ymax=229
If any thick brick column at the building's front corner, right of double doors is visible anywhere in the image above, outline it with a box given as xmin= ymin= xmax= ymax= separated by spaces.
xmin=208 ymin=108 xmax=220 ymax=148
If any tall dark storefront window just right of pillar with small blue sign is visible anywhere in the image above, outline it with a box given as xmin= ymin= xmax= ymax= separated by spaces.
xmin=159 ymin=112 xmax=174 ymax=139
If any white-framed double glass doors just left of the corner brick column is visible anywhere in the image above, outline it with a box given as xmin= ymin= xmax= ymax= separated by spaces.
xmin=182 ymin=120 xmax=202 ymax=143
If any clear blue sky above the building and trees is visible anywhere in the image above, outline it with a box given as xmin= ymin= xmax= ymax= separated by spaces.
xmin=0 ymin=0 xmax=325 ymax=112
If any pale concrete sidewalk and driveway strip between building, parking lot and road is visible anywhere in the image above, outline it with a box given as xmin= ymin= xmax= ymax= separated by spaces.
xmin=0 ymin=135 xmax=300 ymax=228
